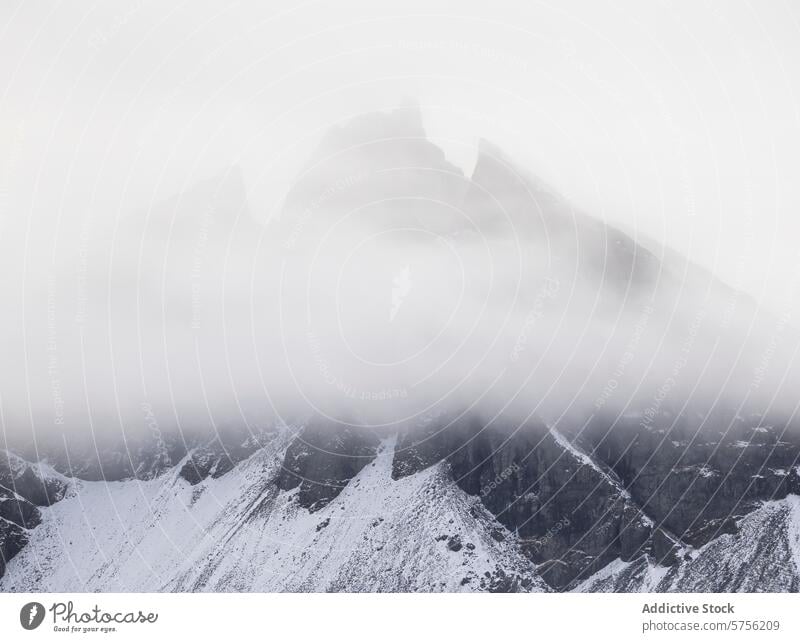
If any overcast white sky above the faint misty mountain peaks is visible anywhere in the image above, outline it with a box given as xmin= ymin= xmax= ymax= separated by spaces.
xmin=0 ymin=0 xmax=800 ymax=311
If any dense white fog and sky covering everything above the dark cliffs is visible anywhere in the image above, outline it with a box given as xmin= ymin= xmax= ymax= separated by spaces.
xmin=0 ymin=0 xmax=800 ymax=445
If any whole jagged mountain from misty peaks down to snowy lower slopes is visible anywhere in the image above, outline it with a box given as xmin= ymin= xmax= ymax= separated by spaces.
xmin=0 ymin=107 xmax=800 ymax=592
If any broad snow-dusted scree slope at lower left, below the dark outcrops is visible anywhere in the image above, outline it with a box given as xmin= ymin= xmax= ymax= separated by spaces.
xmin=0 ymin=434 xmax=547 ymax=591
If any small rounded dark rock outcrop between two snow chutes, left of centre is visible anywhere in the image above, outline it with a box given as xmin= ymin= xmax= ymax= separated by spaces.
xmin=275 ymin=422 xmax=380 ymax=512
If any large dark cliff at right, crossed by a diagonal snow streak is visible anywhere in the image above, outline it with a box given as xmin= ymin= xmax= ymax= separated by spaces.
xmin=393 ymin=415 xmax=800 ymax=589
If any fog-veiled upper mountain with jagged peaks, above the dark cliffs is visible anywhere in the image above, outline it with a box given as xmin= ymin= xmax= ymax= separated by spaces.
xmin=0 ymin=109 xmax=799 ymax=456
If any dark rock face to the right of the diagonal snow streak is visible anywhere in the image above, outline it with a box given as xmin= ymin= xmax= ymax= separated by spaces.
xmin=584 ymin=415 xmax=800 ymax=547
